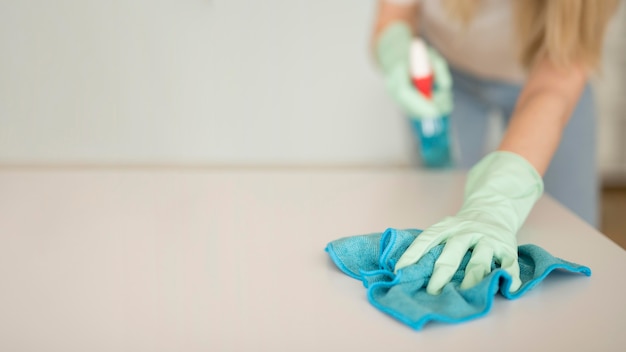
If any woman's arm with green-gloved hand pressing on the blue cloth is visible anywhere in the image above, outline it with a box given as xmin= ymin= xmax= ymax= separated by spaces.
xmin=394 ymin=55 xmax=587 ymax=294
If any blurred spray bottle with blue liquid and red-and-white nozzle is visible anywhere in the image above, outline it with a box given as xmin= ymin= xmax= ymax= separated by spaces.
xmin=409 ymin=38 xmax=452 ymax=168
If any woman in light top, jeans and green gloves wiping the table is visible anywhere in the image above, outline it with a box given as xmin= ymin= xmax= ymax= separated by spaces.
xmin=373 ymin=0 xmax=617 ymax=294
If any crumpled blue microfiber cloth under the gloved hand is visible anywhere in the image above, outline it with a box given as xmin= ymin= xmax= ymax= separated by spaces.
xmin=326 ymin=229 xmax=591 ymax=330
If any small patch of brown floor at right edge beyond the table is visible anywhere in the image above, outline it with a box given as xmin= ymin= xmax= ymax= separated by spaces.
xmin=601 ymin=187 xmax=626 ymax=249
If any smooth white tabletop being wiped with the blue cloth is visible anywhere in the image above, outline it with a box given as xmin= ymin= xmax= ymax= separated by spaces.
xmin=0 ymin=168 xmax=626 ymax=352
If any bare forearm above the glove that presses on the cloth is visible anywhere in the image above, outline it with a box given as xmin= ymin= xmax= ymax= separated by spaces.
xmin=498 ymin=58 xmax=587 ymax=176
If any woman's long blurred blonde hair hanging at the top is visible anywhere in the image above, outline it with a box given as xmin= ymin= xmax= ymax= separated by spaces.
xmin=444 ymin=0 xmax=619 ymax=69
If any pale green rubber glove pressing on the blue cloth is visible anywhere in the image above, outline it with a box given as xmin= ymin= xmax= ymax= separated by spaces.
xmin=395 ymin=151 xmax=543 ymax=294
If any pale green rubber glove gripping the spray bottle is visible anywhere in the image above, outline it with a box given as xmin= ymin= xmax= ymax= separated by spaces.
xmin=376 ymin=22 xmax=452 ymax=119
